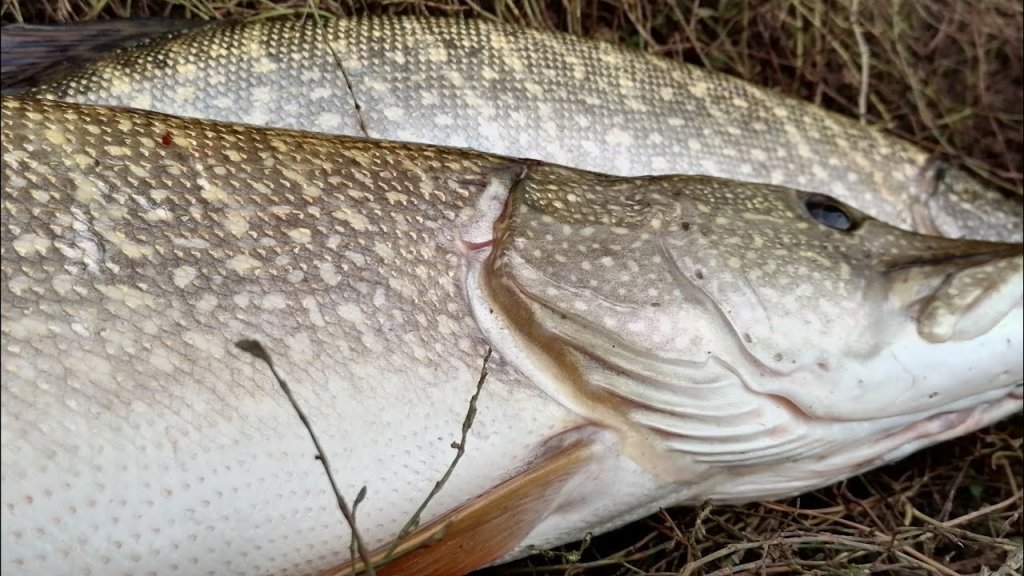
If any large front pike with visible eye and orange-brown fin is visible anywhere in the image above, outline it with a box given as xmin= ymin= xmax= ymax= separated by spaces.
xmin=0 ymin=97 xmax=1024 ymax=575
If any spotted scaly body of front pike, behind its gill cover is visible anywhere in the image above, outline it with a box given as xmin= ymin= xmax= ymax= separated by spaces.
xmin=0 ymin=99 xmax=579 ymax=576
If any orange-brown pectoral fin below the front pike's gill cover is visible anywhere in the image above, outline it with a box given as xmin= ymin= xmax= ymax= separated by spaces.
xmin=325 ymin=430 xmax=593 ymax=576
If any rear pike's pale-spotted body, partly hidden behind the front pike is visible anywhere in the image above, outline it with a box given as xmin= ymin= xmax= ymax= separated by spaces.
xmin=18 ymin=16 xmax=1024 ymax=242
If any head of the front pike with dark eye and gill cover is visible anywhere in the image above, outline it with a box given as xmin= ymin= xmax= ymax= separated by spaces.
xmin=467 ymin=168 xmax=1024 ymax=494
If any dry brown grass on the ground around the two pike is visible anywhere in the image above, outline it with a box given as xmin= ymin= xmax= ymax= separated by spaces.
xmin=2 ymin=0 xmax=1024 ymax=576
